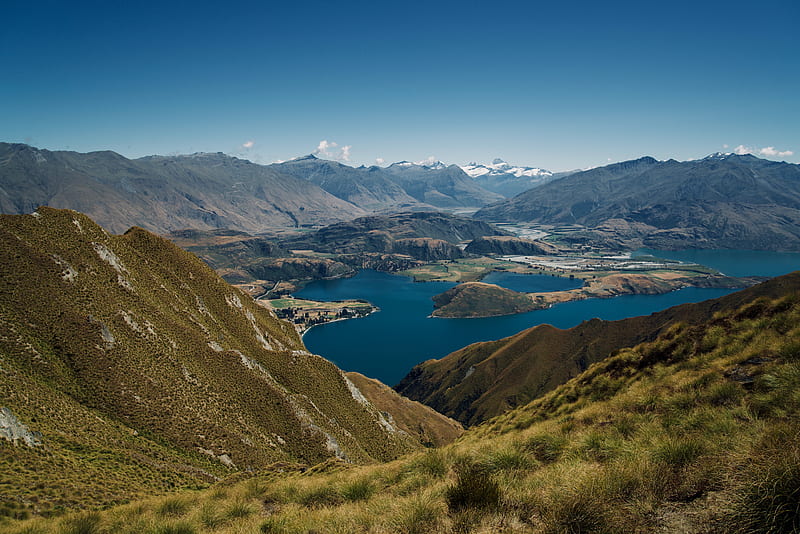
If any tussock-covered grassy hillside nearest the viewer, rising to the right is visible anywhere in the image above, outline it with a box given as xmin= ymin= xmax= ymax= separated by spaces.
xmin=11 ymin=278 xmax=800 ymax=534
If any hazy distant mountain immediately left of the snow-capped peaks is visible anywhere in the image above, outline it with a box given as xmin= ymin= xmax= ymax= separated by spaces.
xmin=386 ymin=161 xmax=503 ymax=208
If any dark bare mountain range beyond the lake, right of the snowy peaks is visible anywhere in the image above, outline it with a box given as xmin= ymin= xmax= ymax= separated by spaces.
xmin=475 ymin=154 xmax=800 ymax=250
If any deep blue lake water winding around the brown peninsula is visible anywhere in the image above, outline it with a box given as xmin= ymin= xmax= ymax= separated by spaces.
xmin=297 ymin=250 xmax=800 ymax=385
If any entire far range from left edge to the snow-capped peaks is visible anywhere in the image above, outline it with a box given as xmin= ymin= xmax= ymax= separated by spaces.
xmin=0 ymin=143 xmax=520 ymax=238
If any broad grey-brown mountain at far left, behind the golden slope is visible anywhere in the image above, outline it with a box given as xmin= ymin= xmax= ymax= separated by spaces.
xmin=0 ymin=143 xmax=365 ymax=234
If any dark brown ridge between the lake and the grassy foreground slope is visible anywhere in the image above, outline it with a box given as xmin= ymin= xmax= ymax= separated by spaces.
xmin=395 ymin=273 xmax=800 ymax=425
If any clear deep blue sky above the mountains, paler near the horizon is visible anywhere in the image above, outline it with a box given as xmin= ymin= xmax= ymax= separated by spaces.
xmin=0 ymin=0 xmax=800 ymax=170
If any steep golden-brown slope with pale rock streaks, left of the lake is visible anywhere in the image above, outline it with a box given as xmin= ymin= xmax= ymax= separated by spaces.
xmin=0 ymin=208 xmax=419 ymax=509
